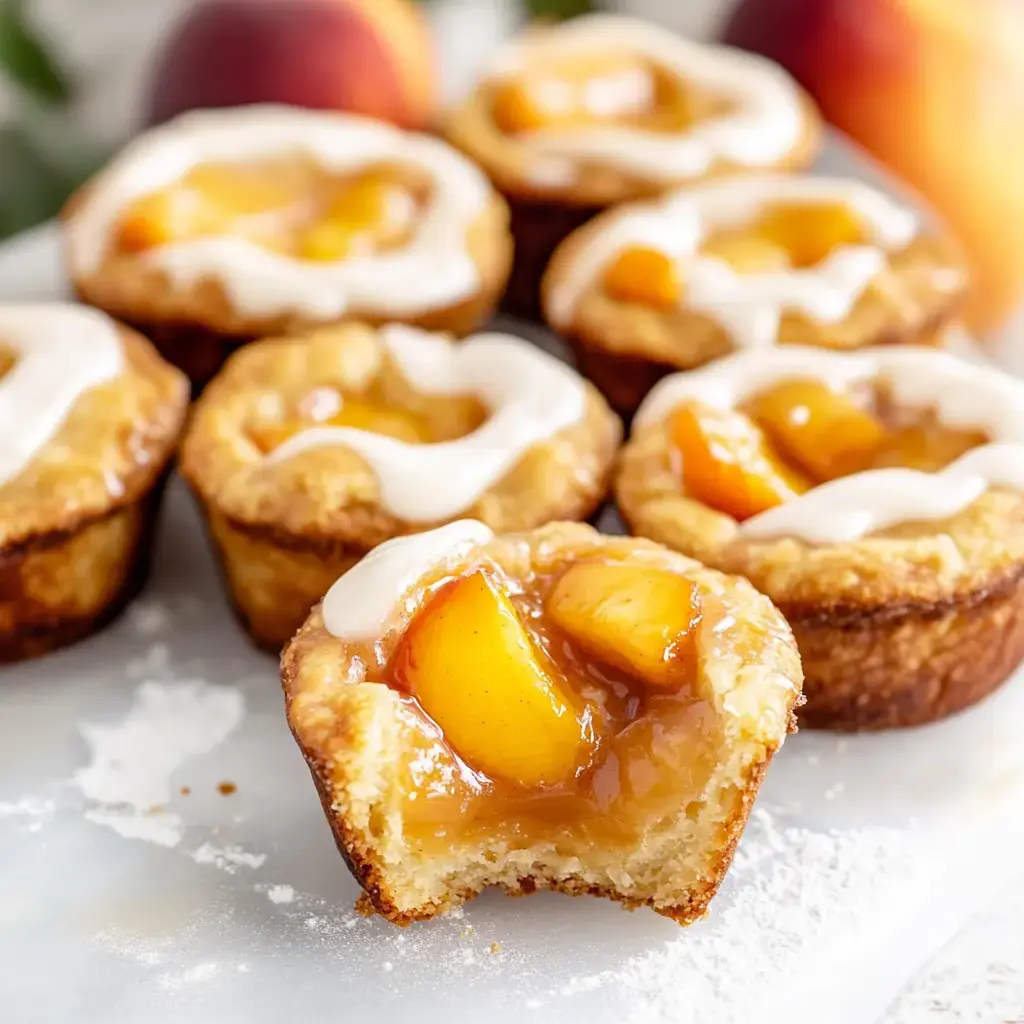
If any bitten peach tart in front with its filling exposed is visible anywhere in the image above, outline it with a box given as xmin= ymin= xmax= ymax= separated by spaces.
xmin=282 ymin=521 xmax=801 ymax=925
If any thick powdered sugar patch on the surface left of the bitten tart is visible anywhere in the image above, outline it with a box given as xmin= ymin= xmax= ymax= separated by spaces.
xmin=72 ymin=680 xmax=245 ymax=847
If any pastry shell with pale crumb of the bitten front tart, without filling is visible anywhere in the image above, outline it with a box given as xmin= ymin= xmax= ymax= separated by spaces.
xmin=282 ymin=523 xmax=801 ymax=925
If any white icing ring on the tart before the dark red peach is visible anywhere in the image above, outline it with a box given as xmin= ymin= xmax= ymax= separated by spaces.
xmin=67 ymin=106 xmax=492 ymax=319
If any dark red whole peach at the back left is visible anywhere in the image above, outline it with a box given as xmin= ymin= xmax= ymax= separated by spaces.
xmin=148 ymin=0 xmax=436 ymax=128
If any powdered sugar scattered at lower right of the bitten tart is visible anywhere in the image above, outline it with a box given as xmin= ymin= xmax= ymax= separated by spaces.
xmin=524 ymin=809 xmax=920 ymax=1024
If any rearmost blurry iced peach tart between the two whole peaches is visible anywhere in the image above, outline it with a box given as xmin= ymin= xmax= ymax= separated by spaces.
xmin=443 ymin=14 xmax=820 ymax=317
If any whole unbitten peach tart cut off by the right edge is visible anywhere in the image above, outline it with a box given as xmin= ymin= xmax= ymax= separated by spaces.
xmin=615 ymin=346 xmax=1024 ymax=729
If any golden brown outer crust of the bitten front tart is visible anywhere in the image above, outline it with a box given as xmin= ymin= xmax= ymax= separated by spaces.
xmin=281 ymin=523 xmax=800 ymax=925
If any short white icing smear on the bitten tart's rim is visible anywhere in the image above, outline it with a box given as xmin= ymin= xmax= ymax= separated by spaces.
xmin=321 ymin=519 xmax=495 ymax=642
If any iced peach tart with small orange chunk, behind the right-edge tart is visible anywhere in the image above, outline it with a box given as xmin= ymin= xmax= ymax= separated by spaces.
xmin=544 ymin=175 xmax=966 ymax=413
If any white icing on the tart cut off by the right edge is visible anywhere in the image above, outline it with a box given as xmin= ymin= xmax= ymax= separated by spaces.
xmin=635 ymin=346 xmax=1024 ymax=544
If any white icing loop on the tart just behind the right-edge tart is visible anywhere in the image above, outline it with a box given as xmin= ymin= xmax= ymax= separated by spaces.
xmin=548 ymin=175 xmax=925 ymax=348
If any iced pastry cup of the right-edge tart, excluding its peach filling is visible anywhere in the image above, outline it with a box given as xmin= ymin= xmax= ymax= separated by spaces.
xmin=615 ymin=347 xmax=1024 ymax=730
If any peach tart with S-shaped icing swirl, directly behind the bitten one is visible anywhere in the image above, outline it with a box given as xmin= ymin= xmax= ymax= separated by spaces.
xmin=181 ymin=325 xmax=622 ymax=650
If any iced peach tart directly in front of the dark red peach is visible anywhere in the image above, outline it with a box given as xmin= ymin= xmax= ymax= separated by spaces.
xmin=62 ymin=106 xmax=512 ymax=388
